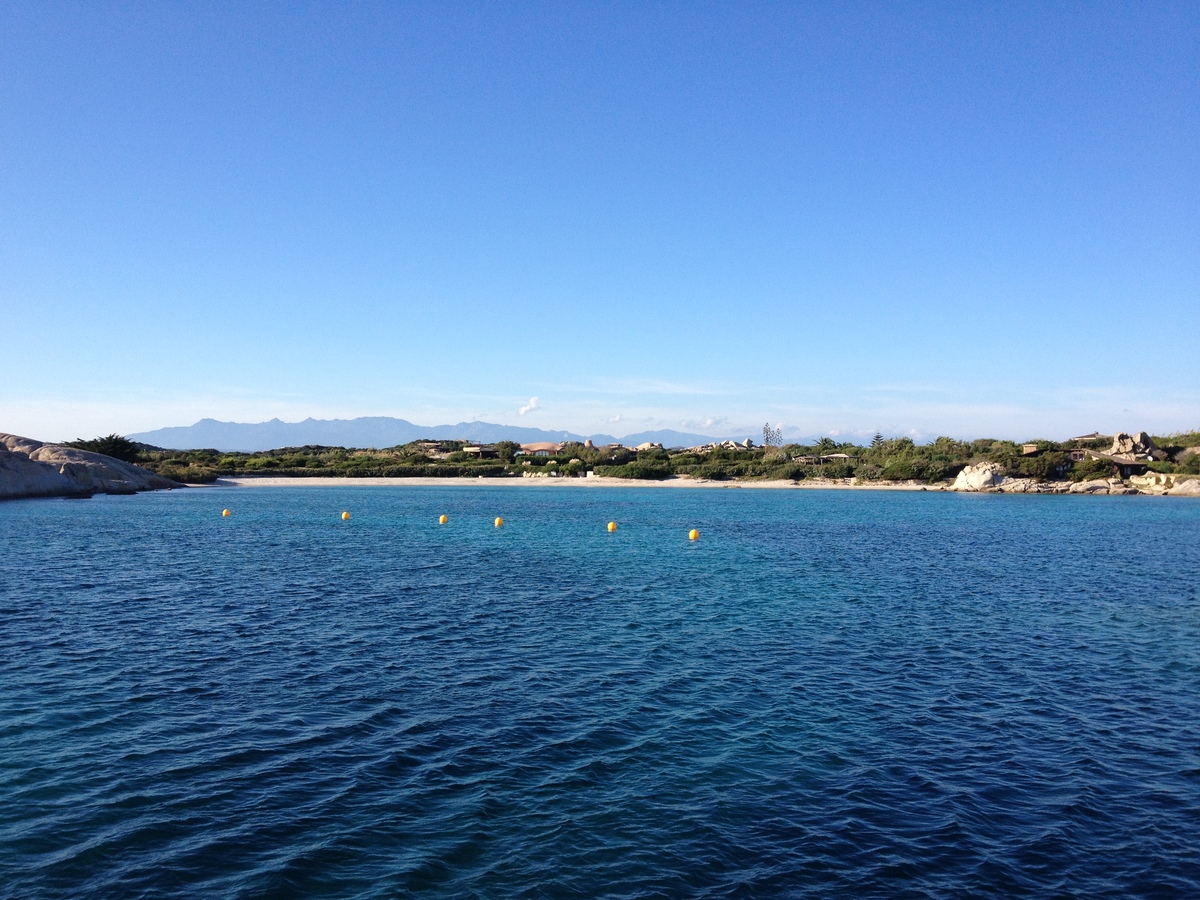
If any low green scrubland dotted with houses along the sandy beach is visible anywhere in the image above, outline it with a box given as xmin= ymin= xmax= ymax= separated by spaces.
xmin=93 ymin=432 xmax=1200 ymax=484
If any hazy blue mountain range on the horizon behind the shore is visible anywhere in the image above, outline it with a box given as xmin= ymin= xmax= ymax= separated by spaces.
xmin=126 ymin=415 xmax=748 ymax=452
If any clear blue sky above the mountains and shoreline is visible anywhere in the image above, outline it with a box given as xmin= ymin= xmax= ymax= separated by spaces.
xmin=0 ymin=0 xmax=1200 ymax=439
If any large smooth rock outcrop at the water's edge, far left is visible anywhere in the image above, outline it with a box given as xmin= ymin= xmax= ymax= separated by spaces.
xmin=0 ymin=433 xmax=182 ymax=499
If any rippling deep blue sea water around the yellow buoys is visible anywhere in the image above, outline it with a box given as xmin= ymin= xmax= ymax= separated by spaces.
xmin=0 ymin=485 xmax=1200 ymax=898
